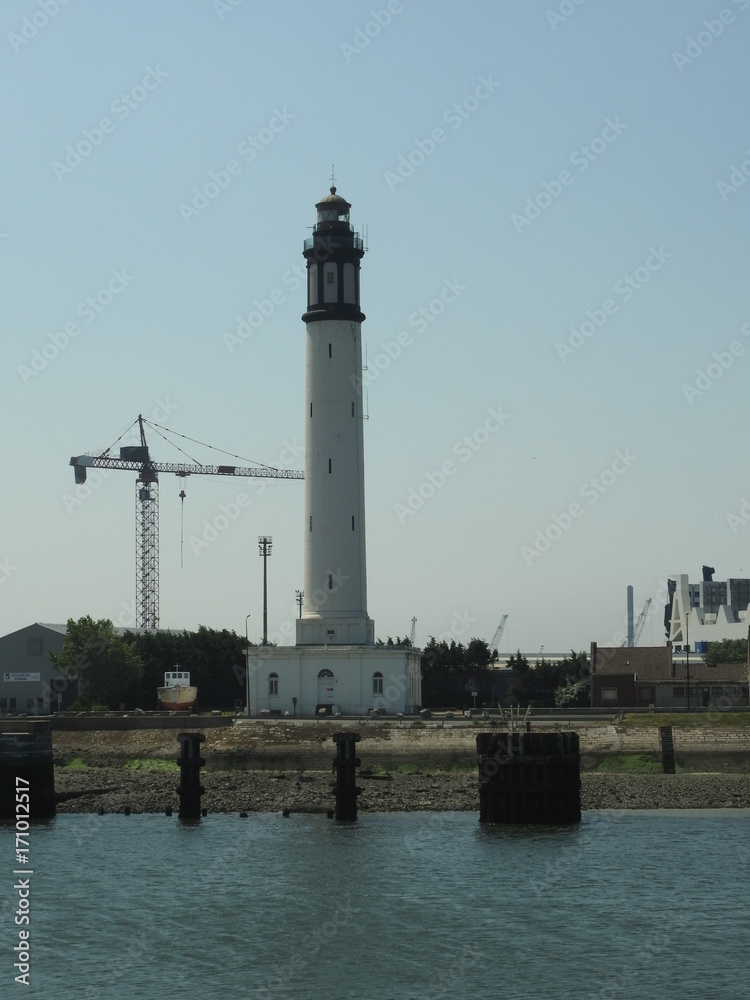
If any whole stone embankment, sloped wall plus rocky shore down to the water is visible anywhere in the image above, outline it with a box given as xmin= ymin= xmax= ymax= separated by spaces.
xmin=53 ymin=719 xmax=750 ymax=812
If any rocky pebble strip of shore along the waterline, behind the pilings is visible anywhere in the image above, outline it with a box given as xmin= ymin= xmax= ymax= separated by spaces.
xmin=55 ymin=767 xmax=750 ymax=813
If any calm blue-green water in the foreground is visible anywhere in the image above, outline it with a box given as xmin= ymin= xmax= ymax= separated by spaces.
xmin=0 ymin=810 xmax=750 ymax=1000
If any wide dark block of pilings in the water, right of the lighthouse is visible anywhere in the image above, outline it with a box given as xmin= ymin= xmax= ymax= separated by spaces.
xmin=477 ymin=732 xmax=581 ymax=824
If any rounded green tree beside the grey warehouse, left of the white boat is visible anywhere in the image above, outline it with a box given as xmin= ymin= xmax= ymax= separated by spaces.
xmin=50 ymin=615 xmax=143 ymax=709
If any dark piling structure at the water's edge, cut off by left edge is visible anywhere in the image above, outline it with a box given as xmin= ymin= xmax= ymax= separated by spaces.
xmin=0 ymin=720 xmax=56 ymax=820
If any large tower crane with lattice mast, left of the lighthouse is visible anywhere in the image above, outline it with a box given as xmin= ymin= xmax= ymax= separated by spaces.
xmin=70 ymin=413 xmax=305 ymax=629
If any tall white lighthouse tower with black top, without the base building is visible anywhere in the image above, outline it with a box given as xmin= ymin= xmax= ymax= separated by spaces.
xmin=297 ymin=187 xmax=375 ymax=645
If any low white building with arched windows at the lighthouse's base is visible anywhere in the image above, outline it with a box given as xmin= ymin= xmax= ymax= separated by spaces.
xmin=247 ymin=644 xmax=421 ymax=717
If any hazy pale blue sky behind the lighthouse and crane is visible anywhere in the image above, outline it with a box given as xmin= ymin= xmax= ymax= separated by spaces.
xmin=0 ymin=0 xmax=750 ymax=652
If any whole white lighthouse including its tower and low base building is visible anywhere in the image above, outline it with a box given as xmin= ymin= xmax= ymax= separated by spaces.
xmin=247 ymin=187 xmax=421 ymax=716
